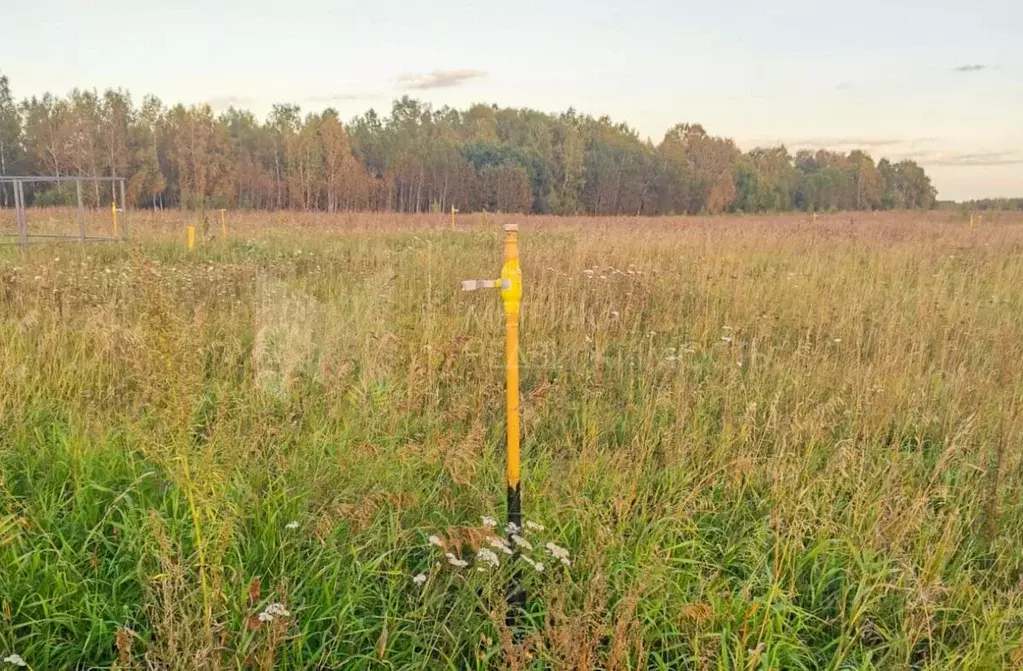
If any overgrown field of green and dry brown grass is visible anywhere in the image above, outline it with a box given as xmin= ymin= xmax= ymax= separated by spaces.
xmin=0 ymin=212 xmax=1023 ymax=670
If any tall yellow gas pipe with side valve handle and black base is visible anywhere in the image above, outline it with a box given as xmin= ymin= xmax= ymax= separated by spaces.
xmin=466 ymin=224 xmax=526 ymax=625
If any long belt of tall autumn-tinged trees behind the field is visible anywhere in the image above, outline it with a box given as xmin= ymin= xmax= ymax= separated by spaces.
xmin=0 ymin=75 xmax=936 ymax=215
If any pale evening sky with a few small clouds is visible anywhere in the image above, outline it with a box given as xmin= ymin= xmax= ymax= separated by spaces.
xmin=0 ymin=0 xmax=1023 ymax=199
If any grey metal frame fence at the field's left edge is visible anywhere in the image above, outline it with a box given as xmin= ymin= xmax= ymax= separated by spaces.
xmin=0 ymin=175 xmax=128 ymax=247
